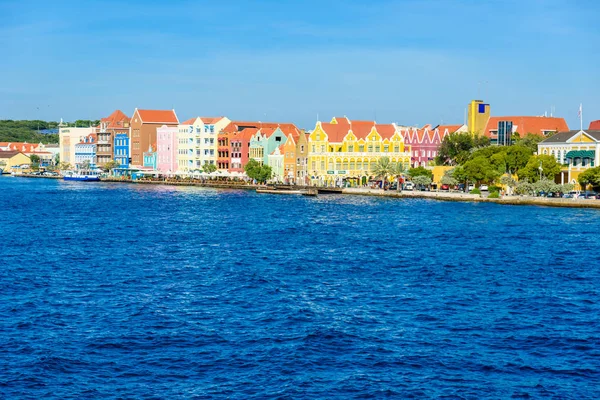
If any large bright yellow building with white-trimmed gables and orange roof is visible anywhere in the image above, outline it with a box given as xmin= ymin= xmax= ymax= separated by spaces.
xmin=308 ymin=117 xmax=410 ymax=185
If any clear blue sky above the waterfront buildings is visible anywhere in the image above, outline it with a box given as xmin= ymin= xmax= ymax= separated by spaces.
xmin=0 ymin=0 xmax=600 ymax=129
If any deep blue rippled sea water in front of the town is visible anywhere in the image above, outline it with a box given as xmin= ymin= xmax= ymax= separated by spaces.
xmin=0 ymin=177 xmax=600 ymax=399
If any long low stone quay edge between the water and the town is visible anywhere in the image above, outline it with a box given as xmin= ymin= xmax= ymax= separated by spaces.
xmin=8 ymin=175 xmax=600 ymax=209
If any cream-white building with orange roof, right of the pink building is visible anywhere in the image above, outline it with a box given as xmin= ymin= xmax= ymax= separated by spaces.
xmin=177 ymin=117 xmax=231 ymax=172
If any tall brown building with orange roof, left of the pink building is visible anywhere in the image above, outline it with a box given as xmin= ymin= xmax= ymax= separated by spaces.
xmin=129 ymin=108 xmax=179 ymax=167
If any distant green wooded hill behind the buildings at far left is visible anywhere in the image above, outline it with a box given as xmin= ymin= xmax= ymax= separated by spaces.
xmin=0 ymin=119 xmax=100 ymax=144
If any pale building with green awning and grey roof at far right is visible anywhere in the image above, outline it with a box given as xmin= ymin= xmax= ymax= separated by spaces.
xmin=538 ymin=130 xmax=600 ymax=188
